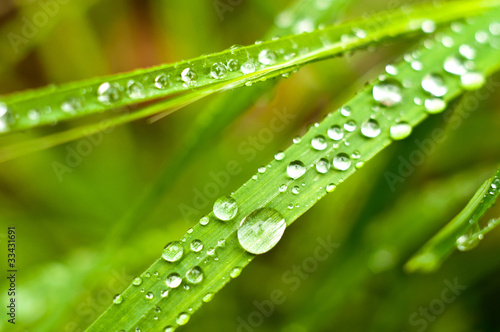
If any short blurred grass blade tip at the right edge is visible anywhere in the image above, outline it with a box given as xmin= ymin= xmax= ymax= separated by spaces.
xmin=405 ymin=165 xmax=500 ymax=272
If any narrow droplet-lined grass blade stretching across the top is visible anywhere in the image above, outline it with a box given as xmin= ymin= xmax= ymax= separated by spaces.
xmin=0 ymin=0 xmax=500 ymax=133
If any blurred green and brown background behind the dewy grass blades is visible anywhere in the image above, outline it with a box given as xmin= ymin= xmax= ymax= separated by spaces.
xmin=0 ymin=0 xmax=500 ymax=332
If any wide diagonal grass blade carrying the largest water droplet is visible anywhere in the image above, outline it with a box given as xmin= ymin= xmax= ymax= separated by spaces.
xmin=88 ymin=10 xmax=500 ymax=331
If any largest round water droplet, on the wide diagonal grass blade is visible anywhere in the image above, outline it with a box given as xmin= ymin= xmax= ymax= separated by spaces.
xmin=238 ymin=208 xmax=286 ymax=255
